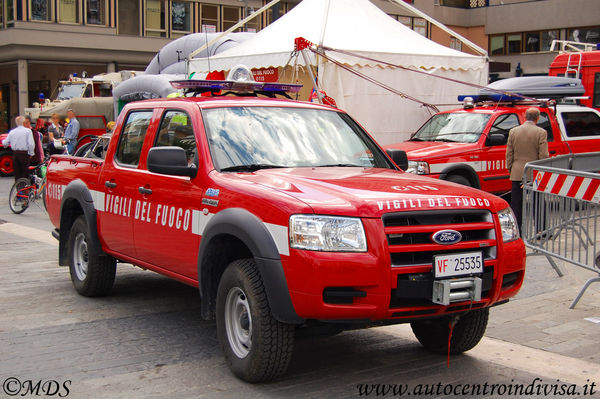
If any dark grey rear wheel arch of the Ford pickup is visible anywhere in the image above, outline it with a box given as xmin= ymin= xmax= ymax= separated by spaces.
xmin=58 ymin=179 xmax=106 ymax=266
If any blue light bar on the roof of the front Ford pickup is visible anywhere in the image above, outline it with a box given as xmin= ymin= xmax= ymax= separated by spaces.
xmin=171 ymin=80 xmax=302 ymax=93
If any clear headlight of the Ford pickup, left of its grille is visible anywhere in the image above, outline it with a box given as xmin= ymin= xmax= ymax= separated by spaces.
xmin=290 ymin=215 xmax=367 ymax=252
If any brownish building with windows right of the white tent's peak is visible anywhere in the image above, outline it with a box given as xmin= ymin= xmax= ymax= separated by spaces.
xmin=406 ymin=0 xmax=600 ymax=79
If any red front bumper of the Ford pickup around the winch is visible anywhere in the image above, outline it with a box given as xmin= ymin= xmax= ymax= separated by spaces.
xmin=282 ymin=215 xmax=525 ymax=322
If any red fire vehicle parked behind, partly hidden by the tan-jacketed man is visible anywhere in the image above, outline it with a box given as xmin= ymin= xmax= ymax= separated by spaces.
xmin=386 ymin=102 xmax=600 ymax=195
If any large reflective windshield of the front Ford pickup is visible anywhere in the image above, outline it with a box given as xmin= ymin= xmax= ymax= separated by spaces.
xmin=203 ymin=107 xmax=394 ymax=171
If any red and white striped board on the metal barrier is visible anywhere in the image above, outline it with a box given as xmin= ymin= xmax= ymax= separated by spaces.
xmin=533 ymin=169 xmax=600 ymax=203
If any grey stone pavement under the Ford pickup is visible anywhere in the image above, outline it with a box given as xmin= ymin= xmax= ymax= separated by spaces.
xmin=0 ymin=178 xmax=600 ymax=398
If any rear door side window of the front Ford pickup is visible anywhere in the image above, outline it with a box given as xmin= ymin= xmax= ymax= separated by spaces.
xmin=115 ymin=111 xmax=152 ymax=166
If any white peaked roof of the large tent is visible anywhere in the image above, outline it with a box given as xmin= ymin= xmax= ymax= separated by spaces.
xmin=188 ymin=0 xmax=486 ymax=72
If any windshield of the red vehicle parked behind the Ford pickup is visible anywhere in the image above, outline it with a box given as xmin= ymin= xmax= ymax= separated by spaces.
xmin=410 ymin=112 xmax=491 ymax=143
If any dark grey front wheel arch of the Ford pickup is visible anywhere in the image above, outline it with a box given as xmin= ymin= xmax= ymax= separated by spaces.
xmin=198 ymin=208 xmax=303 ymax=323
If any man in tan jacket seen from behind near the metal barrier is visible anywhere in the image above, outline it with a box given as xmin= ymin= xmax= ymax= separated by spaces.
xmin=506 ymin=108 xmax=549 ymax=231
